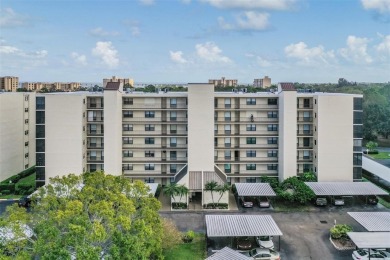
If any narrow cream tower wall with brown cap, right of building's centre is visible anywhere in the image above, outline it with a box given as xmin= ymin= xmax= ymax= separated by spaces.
xmin=279 ymin=91 xmax=297 ymax=181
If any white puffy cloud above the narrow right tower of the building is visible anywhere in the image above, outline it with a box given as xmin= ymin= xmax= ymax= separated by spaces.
xmin=284 ymin=42 xmax=335 ymax=65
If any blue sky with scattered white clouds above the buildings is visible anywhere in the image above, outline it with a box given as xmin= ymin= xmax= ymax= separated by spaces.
xmin=0 ymin=0 xmax=390 ymax=83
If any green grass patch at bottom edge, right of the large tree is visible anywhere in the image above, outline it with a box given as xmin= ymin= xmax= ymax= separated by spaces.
xmin=164 ymin=233 xmax=207 ymax=260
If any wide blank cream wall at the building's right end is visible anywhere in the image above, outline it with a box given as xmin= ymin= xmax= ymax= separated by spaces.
xmin=314 ymin=94 xmax=353 ymax=181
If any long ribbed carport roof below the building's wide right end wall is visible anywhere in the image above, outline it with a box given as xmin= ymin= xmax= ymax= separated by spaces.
xmin=305 ymin=182 xmax=389 ymax=196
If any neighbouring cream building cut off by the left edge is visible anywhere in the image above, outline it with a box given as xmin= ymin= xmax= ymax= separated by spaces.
xmin=0 ymin=92 xmax=35 ymax=181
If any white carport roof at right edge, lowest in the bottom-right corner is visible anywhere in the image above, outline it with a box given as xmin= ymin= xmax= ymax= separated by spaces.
xmin=347 ymin=232 xmax=390 ymax=249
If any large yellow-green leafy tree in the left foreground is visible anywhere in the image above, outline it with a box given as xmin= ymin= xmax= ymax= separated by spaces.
xmin=0 ymin=172 xmax=163 ymax=259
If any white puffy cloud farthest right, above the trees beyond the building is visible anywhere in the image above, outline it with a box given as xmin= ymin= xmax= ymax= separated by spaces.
xmin=339 ymin=35 xmax=372 ymax=63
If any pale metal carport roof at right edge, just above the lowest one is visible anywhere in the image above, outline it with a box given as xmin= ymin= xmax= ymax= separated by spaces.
xmin=348 ymin=212 xmax=390 ymax=232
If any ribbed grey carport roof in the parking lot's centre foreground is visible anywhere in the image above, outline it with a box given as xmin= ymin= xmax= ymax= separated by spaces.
xmin=206 ymin=215 xmax=283 ymax=237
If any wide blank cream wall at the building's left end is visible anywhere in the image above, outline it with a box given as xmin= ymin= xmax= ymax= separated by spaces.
xmin=45 ymin=94 xmax=86 ymax=183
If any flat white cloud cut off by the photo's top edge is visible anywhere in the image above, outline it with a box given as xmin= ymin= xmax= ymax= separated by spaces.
xmin=201 ymin=0 xmax=296 ymax=10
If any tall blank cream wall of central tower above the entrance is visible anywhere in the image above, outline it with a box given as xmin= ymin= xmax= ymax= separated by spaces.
xmin=188 ymin=84 xmax=214 ymax=171
